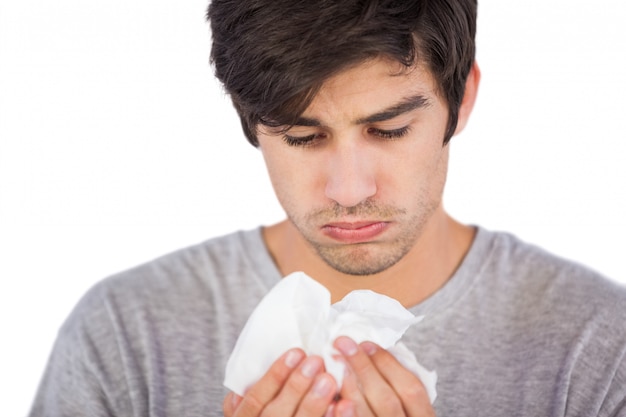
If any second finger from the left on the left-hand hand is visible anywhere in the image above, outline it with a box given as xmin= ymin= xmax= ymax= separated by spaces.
xmin=263 ymin=356 xmax=324 ymax=417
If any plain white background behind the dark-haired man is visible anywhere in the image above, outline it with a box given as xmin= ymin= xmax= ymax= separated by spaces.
xmin=0 ymin=0 xmax=626 ymax=416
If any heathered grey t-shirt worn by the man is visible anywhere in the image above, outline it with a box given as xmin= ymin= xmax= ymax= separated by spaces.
xmin=31 ymin=228 xmax=626 ymax=417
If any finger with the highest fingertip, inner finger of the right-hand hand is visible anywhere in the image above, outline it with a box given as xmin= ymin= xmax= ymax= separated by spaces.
xmin=334 ymin=336 xmax=405 ymax=416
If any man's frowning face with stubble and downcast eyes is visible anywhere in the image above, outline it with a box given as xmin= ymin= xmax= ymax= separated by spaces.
xmin=258 ymin=59 xmax=448 ymax=275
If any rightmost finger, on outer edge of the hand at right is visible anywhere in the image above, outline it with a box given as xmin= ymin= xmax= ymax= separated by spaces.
xmin=361 ymin=342 xmax=435 ymax=417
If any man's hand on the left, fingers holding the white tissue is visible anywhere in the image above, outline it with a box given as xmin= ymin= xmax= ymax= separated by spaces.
xmin=223 ymin=349 xmax=337 ymax=417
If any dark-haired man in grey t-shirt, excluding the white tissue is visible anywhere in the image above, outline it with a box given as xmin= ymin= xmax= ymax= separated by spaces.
xmin=32 ymin=0 xmax=626 ymax=417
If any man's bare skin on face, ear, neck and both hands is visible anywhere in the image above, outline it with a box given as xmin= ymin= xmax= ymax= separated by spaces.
xmin=224 ymin=58 xmax=480 ymax=417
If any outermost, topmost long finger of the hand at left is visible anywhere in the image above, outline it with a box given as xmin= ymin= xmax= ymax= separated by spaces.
xmin=235 ymin=349 xmax=305 ymax=417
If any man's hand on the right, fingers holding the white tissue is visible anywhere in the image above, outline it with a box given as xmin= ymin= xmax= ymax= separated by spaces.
xmin=333 ymin=336 xmax=435 ymax=417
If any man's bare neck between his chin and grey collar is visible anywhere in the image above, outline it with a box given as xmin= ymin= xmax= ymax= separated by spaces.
xmin=263 ymin=208 xmax=475 ymax=307
